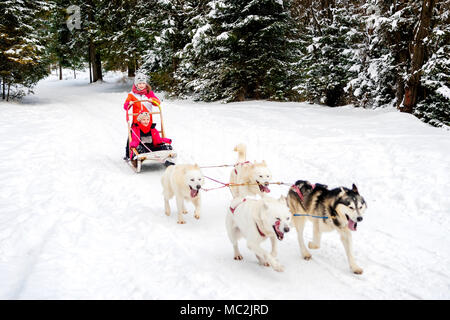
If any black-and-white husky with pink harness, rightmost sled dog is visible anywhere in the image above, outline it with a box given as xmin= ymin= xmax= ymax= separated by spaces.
xmin=287 ymin=180 xmax=367 ymax=274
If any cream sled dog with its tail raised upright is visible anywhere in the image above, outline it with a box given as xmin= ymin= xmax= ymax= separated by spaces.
xmin=230 ymin=143 xmax=272 ymax=198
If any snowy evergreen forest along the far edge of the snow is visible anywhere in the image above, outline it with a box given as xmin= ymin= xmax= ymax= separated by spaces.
xmin=0 ymin=0 xmax=450 ymax=126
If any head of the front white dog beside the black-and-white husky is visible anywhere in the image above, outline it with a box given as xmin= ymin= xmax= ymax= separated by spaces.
xmin=260 ymin=196 xmax=291 ymax=240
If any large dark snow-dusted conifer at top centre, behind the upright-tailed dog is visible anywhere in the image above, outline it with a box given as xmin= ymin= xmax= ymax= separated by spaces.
xmin=178 ymin=0 xmax=294 ymax=101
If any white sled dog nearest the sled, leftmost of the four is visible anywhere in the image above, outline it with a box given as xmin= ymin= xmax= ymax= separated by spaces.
xmin=161 ymin=164 xmax=205 ymax=224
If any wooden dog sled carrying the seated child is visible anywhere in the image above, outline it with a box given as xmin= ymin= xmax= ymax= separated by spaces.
xmin=126 ymin=100 xmax=177 ymax=173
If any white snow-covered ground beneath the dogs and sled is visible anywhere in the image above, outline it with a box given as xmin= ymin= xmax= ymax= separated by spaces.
xmin=0 ymin=70 xmax=450 ymax=299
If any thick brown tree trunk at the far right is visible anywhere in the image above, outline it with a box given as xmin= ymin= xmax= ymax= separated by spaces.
xmin=398 ymin=0 xmax=435 ymax=113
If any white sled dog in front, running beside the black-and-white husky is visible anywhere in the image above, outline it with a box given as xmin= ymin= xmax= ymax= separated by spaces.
xmin=226 ymin=197 xmax=291 ymax=271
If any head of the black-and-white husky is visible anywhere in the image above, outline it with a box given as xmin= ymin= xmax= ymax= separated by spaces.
xmin=335 ymin=184 xmax=367 ymax=231
